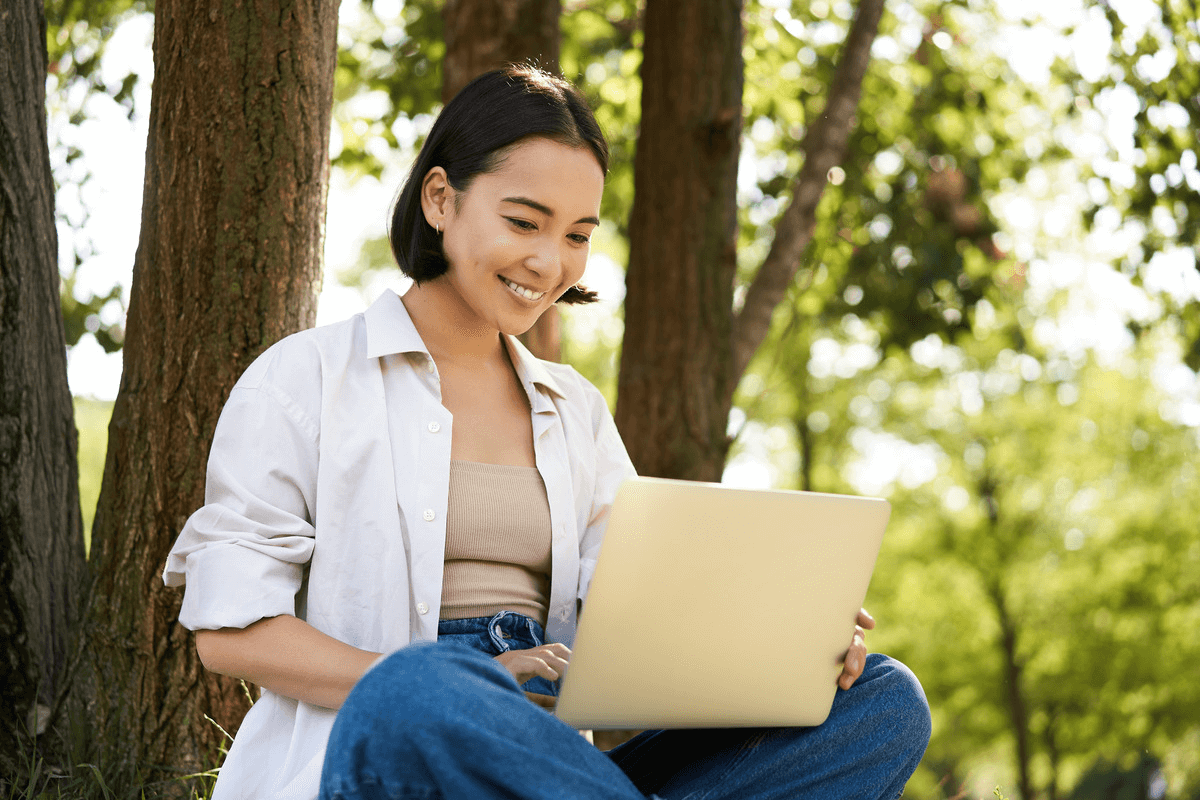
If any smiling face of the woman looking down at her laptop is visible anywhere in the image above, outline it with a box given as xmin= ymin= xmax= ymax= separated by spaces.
xmin=425 ymin=138 xmax=604 ymax=335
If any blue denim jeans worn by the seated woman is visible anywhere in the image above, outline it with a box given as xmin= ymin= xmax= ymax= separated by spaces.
xmin=320 ymin=613 xmax=930 ymax=800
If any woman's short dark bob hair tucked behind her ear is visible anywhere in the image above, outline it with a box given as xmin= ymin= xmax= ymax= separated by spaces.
xmin=388 ymin=65 xmax=608 ymax=303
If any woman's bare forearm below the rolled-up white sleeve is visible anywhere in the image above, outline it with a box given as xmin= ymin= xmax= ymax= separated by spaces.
xmin=196 ymin=615 xmax=379 ymax=709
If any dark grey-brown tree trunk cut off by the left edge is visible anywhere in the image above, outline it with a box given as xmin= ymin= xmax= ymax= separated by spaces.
xmin=0 ymin=0 xmax=85 ymax=775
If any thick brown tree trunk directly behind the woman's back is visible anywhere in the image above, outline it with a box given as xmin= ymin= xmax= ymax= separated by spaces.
xmin=75 ymin=0 xmax=337 ymax=789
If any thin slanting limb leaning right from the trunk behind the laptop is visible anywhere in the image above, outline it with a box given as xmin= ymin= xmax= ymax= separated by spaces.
xmin=733 ymin=0 xmax=883 ymax=375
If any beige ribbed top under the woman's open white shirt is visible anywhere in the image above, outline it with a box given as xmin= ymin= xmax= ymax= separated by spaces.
xmin=440 ymin=461 xmax=551 ymax=626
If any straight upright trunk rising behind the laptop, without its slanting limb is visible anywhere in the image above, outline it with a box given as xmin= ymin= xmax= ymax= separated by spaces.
xmin=617 ymin=0 xmax=744 ymax=481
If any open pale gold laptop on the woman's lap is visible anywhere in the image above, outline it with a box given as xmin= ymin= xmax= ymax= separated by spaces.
xmin=556 ymin=477 xmax=892 ymax=729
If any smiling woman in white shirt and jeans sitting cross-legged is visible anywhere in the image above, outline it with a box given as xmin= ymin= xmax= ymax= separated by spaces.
xmin=164 ymin=67 xmax=928 ymax=800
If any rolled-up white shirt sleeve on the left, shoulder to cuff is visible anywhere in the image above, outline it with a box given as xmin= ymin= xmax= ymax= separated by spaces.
xmin=163 ymin=381 xmax=319 ymax=631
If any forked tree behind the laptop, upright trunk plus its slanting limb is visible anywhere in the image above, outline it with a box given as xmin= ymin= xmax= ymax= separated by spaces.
xmin=617 ymin=0 xmax=883 ymax=481
